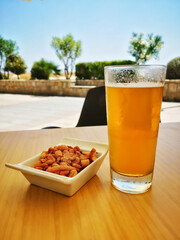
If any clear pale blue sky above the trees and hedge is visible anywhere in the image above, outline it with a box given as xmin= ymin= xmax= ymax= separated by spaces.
xmin=0 ymin=0 xmax=180 ymax=71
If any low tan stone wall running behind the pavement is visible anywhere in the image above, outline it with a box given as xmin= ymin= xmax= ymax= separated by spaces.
xmin=0 ymin=79 xmax=180 ymax=101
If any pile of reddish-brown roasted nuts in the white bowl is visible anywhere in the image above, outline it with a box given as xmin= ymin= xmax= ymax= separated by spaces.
xmin=34 ymin=145 xmax=97 ymax=177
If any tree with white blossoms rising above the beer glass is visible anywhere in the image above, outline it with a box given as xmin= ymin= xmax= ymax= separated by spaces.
xmin=129 ymin=33 xmax=164 ymax=64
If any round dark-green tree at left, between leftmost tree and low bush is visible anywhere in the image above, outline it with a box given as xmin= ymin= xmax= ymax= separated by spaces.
xmin=4 ymin=55 xmax=27 ymax=79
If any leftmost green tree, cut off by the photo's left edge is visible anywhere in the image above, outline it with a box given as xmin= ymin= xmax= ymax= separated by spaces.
xmin=0 ymin=36 xmax=18 ymax=78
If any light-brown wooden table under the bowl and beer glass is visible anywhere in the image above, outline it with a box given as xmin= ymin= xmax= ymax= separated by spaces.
xmin=0 ymin=123 xmax=180 ymax=240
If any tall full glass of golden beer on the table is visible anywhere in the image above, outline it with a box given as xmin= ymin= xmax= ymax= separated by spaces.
xmin=105 ymin=65 xmax=166 ymax=193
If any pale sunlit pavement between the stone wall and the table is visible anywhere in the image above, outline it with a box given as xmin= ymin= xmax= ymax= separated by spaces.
xmin=0 ymin=94 xmax=180 ymax=131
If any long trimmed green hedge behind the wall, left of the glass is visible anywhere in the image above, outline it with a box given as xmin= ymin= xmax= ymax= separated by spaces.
xmin=76 ymin=60 xmax=135 ymax=79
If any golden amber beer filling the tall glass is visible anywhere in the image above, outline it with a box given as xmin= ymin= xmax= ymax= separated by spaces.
xmin=106 ymin=84 xmax=163 ymax=177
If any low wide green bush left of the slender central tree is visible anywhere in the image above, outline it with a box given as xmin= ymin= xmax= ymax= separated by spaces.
xmin=31 ymin=59 xmax=60 ymax=80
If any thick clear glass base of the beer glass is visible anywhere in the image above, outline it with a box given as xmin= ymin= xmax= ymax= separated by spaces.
xmin=111 ymin=169 xmax=153 ymax=194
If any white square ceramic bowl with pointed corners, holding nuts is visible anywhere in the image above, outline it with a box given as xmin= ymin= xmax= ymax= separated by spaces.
xmin=5 ymin=138 xmax=108 ymax=196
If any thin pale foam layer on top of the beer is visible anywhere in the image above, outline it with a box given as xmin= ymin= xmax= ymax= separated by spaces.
xmin=105 ymin=82 xmax=164 ymax=88
